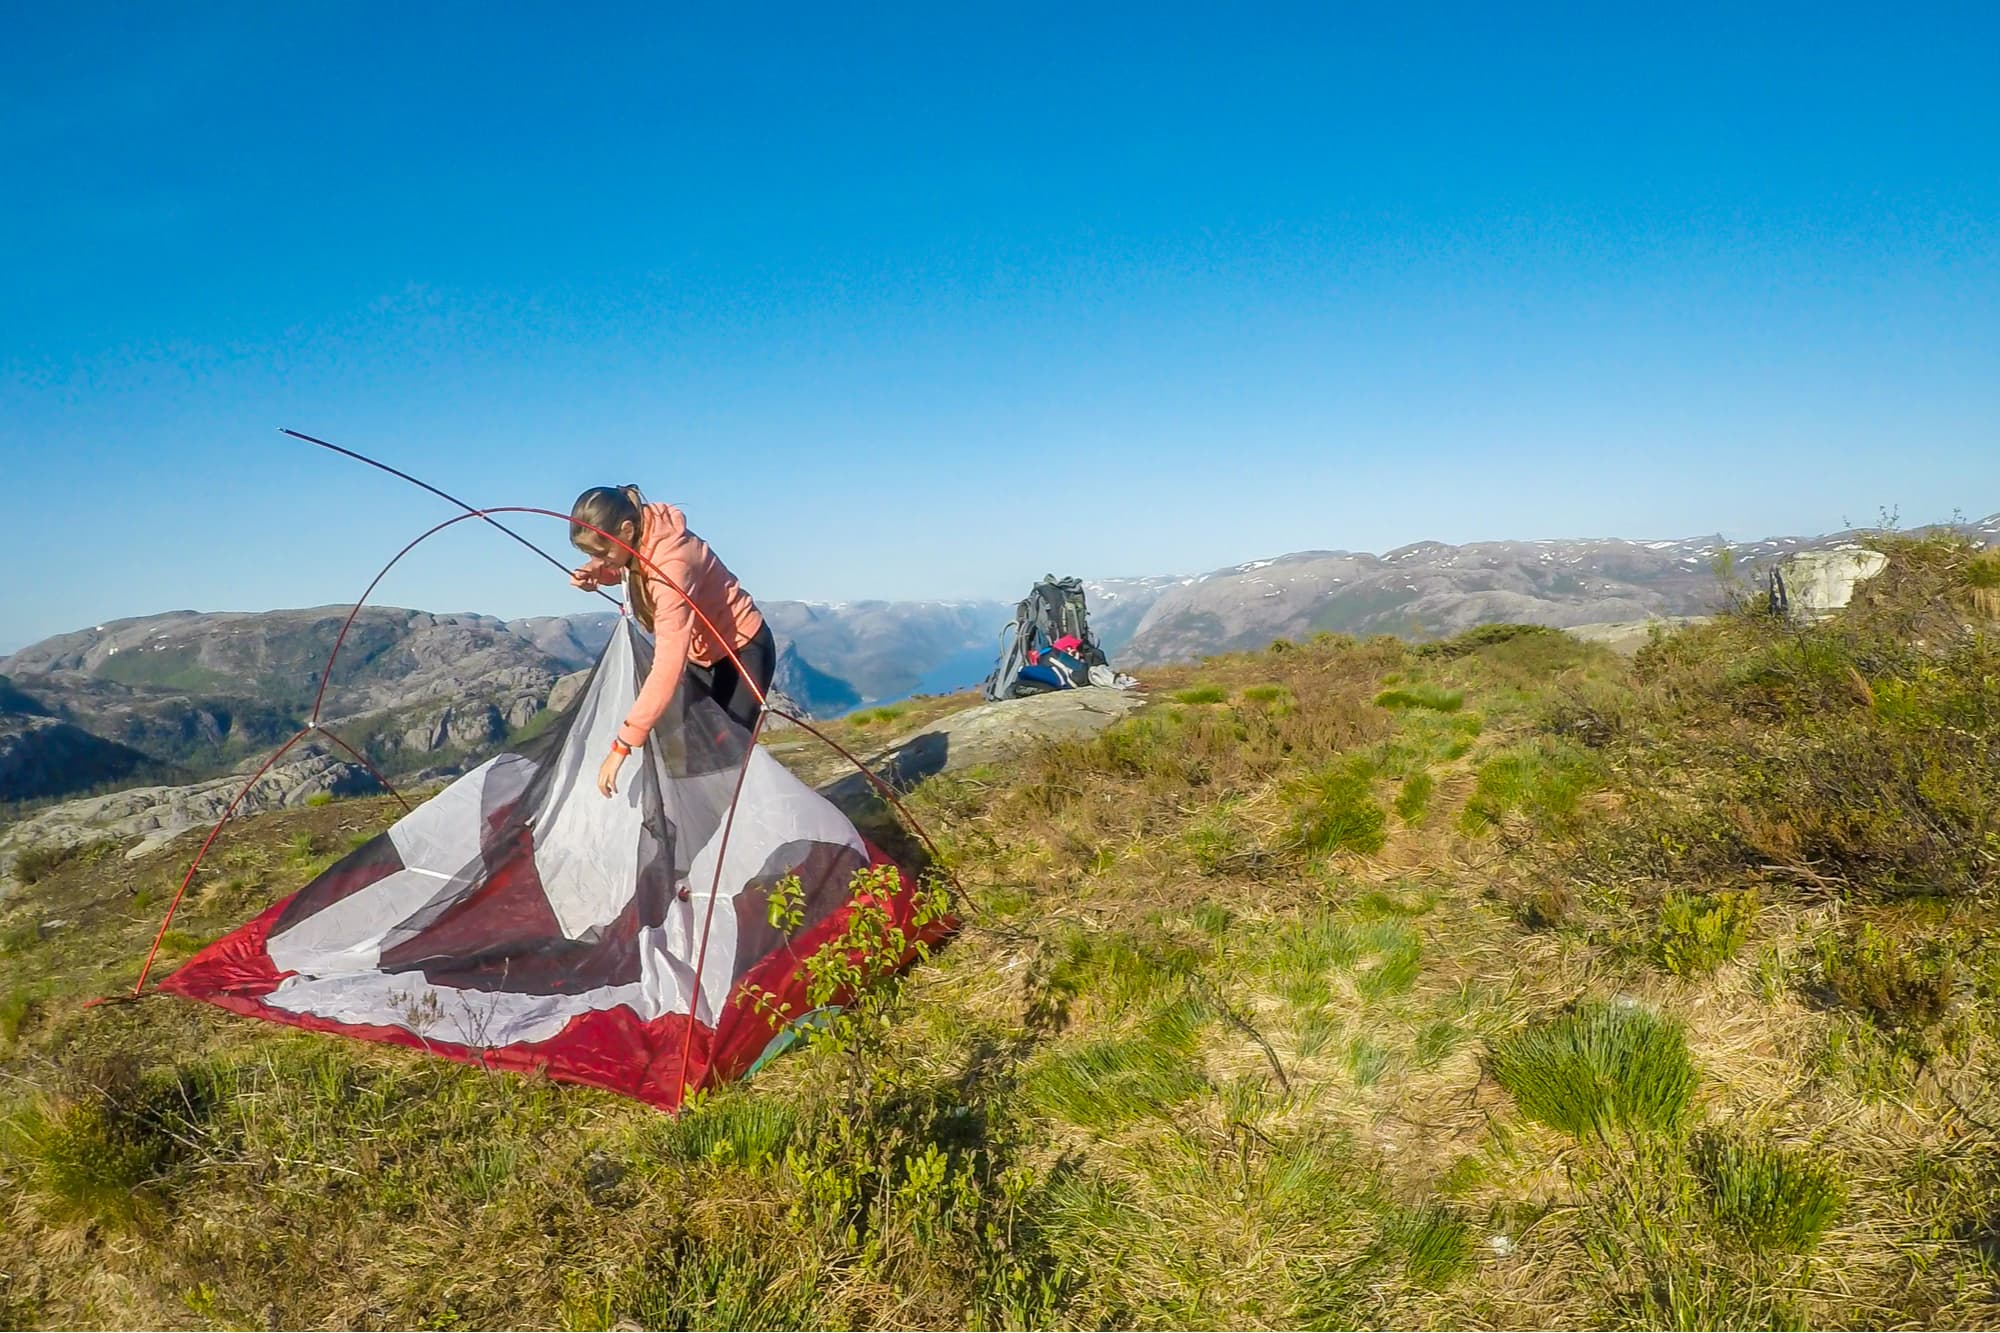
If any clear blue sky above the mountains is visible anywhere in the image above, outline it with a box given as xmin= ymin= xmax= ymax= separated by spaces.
xmin=0 ymin=4 xmax=2000 ymax=650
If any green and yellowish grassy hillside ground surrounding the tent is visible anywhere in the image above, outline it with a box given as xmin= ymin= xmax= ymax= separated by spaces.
xmin=11 ymin=542 xmax=2000 ymax=1329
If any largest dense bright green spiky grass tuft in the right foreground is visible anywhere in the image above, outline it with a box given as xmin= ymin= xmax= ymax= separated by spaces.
xmin=1490 ymin=1003 xmax=1694 ymax=1137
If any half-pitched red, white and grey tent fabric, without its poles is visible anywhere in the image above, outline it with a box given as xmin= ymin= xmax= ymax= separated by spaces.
xmin=154 ymin=556 xmax=950 ymax=1109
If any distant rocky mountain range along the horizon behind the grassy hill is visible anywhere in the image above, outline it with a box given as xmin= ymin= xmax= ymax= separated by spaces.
xmin=0 ymin=514 xmax=2000 ymax=803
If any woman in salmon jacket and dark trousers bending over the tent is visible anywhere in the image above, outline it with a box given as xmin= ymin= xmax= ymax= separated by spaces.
xmin=570 ymin=486 xmax=778 ymax=797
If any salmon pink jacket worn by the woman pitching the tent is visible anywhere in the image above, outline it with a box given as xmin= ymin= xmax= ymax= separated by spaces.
xmin=598 ymin=504 xmax=764 ymax=745
